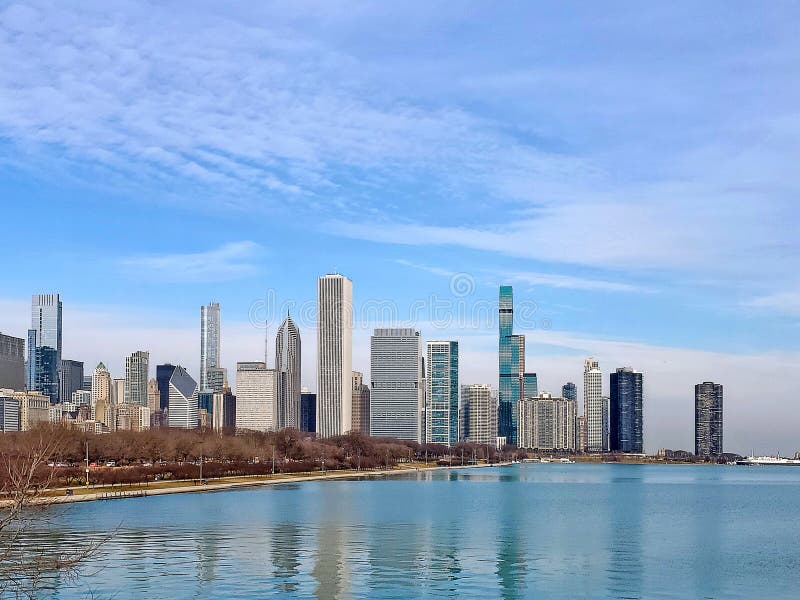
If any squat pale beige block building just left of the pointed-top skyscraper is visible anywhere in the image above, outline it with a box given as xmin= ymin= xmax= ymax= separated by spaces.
xmin=236 ymin=362 xmax=276 ymax=431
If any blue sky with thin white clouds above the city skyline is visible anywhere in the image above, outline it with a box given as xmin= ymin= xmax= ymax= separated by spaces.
xmin=0 ymin=2 xmax=800 ymax=451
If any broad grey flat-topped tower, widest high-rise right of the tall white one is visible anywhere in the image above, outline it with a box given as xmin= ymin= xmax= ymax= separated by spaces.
xmin=370 ymin=328 xmax=423 ymax=442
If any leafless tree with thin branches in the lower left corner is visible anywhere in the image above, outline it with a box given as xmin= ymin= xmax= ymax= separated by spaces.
xmin=0 ymin=428 xmax=107 ymax=599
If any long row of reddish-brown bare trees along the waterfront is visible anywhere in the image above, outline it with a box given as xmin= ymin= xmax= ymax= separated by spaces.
xmin=0 ymin=425 xmax=512 ymax=487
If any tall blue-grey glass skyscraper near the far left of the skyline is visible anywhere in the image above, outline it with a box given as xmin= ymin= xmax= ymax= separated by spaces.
xmin=27 ymin=294 xmax=62 ymax=403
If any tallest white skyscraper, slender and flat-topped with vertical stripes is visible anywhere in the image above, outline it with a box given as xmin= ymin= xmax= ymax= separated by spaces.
xmin=318 ymin=274 xmax=353 ymax=437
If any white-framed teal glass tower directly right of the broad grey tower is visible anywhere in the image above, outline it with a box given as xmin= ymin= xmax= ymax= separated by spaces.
xmin=425 ymin=341 xmax=459 ymax=446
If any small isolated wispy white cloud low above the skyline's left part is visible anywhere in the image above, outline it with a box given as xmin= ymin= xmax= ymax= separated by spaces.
xmin=121 ymin=241 xmax=263 ymax=283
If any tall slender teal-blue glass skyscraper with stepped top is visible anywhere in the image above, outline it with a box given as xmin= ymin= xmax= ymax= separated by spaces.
xmin=497 ymin=285 xmax=525 ymax=444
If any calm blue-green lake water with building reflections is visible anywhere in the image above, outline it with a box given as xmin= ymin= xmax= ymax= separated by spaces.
xmin=28 ymin=464 xmax=800 ymax=599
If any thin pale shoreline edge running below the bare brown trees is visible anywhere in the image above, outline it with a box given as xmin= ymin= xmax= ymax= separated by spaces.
xmin=20 ymin=462 xmax=514 ymax=507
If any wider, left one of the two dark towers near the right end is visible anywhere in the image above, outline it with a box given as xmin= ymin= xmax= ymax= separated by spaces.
xmin=608 ymin=367 xmax=644 ymax=454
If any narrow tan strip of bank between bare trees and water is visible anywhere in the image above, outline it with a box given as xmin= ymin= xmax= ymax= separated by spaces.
xmin=9 ymin=462 xmax=512 ymax=507
